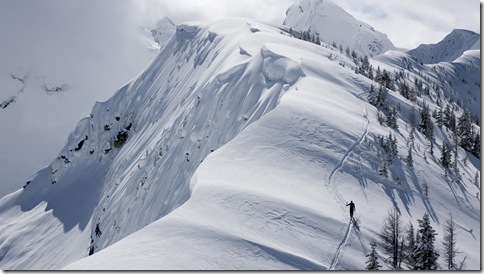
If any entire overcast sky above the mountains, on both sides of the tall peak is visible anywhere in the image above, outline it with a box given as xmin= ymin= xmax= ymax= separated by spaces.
xmin=0 ymin=0 xmax=480 ymax=57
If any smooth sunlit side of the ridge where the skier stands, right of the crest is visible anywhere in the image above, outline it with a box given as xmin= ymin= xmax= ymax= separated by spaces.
xmin=65 ymin=25 xmax=481 ymax=270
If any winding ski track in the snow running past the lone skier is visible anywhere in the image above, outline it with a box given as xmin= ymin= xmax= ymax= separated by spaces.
xmin=326 ymin=101 xmax=371 ymax=270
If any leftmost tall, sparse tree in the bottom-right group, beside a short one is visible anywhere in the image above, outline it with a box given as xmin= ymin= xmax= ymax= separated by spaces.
xmin=380 ymin=209 xmax=402 ymax=268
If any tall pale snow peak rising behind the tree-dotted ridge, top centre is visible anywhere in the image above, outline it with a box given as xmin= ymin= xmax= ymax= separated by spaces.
xmin=283 ymin=0 xmax=395 ymax=56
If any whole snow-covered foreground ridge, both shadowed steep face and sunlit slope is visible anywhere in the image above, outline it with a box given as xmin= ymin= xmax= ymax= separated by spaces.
xmin=0 ymin=19 xmax=480 ymax=270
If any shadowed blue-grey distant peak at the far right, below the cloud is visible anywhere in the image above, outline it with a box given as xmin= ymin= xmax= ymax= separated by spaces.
xmin=408 ymin=29 xmax=481 ymax=64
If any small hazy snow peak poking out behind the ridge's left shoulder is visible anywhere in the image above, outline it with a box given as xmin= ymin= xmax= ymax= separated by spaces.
xmin=139 ymin=17 xmax=176 ymax=51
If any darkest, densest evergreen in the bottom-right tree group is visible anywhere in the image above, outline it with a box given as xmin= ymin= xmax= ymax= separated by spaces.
xmin=413 ymin=213 xmax=439 ymax=270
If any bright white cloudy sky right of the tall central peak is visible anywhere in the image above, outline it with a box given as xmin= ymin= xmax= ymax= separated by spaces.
xmin=334 ymin=0 xmax=480 ymax=48
